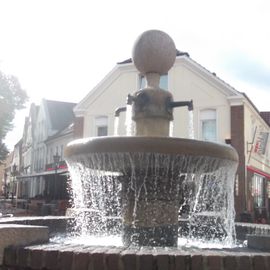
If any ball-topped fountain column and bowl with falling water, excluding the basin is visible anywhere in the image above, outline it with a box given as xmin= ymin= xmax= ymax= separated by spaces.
xmin=65 ymin=30 xmax=238 ymax=246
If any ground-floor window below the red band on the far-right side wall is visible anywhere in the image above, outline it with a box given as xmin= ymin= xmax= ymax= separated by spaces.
xmin=252 ymin=174 xmax=266 ymax=207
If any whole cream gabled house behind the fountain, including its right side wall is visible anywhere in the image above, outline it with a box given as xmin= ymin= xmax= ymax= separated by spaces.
xmin=74 ymin=51 xmax=270 ymax=221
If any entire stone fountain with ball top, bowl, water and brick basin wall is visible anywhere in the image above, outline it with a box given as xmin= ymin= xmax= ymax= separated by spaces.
xmin=4 ymin=31 xmax=270 ymax=270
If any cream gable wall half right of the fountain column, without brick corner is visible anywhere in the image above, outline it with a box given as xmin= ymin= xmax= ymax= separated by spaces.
xmin=169 ymin=60 xmax=230 ymax=143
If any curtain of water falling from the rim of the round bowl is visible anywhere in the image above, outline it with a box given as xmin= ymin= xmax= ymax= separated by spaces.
xmin=67 ymin=153 xmax=237 ymax=247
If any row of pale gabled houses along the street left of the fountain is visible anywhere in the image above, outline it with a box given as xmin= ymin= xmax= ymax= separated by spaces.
xmin=17 ymin=99 xmax=76 ymax=206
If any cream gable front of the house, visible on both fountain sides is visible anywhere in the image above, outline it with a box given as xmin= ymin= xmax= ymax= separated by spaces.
xmin=74 ymin=56 xmax=240 ymax=143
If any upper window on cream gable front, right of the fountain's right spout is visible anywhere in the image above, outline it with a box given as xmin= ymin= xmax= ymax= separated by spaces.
xmin=200 ymin=109 xmax=217 ymax=142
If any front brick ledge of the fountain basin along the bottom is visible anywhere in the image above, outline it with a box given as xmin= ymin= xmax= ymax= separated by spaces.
xmin=3 ymin=243 xmax=270 ymax=270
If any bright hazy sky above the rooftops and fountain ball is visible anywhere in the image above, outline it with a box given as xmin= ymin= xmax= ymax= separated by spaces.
xmin=0 ymin=0 xmax=270 ymax=149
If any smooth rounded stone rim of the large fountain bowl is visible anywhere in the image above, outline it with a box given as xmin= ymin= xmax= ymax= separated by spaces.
xmin=64 ymin=136 xmax=239 ymax=162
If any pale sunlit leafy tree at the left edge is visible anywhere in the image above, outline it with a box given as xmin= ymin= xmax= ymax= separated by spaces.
xmin=0 ymin=71 xmax=28 ymax=164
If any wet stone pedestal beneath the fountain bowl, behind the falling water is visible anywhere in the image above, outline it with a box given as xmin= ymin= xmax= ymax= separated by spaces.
xmin=122 ymin=172 xmax=179 ymax=246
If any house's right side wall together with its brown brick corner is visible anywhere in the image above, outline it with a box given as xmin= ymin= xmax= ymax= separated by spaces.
xmin=231 ymin=101 xmax=270 ymax=222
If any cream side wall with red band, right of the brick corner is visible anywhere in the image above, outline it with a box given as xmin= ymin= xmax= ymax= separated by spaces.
xmin=244 ymin=104 xmax=270 ymax=222
